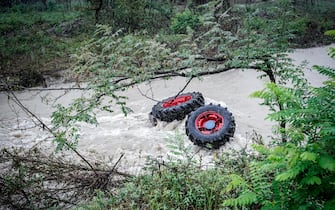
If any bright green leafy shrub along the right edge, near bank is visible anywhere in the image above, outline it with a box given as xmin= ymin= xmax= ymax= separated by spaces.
xmin=242 ymin=48 xmax=335 ymax=209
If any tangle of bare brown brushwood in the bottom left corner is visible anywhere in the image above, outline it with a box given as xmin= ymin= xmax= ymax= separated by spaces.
xmin=0 ymin=148 xmax=132 ymax=209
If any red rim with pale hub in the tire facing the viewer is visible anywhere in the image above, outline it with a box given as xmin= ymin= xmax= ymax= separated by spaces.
xmin=195 ymin=111 xmax=224 ymax=135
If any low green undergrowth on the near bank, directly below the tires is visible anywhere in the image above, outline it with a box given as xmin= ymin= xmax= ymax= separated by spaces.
xmin=77 ymin=133 xmax=264 ymax=209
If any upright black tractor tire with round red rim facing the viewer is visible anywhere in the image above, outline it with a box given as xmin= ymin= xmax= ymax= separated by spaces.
xmin=185 ymin=104 xmax=235 ymax=149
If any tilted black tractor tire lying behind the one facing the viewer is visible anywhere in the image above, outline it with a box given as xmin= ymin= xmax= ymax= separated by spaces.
xmin=151 ymin=92 xmax=205 ymax=122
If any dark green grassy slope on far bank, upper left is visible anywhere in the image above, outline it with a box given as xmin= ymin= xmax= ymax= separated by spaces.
xmin=0 ymin=5 xmax=94 ymax=87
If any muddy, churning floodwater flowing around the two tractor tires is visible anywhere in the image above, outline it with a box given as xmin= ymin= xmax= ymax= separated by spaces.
xmin=0 ymin=44 xmax=335 ymax=173
